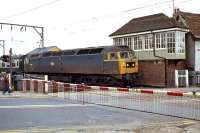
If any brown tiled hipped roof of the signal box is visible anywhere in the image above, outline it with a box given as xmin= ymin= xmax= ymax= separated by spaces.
xmin=109 ymin=13 xmax=186 ymax=36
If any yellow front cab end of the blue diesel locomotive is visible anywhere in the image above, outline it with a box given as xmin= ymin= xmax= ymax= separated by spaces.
xmin=104 ymin=49 xmax=138 ymax=86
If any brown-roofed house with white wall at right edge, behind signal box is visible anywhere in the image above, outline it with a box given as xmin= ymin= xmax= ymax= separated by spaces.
xmin=173 ymin=9 xmax=200 ymax=84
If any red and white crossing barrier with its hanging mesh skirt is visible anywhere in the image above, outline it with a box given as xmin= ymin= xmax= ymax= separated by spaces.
xmin=19 ymin=80 xmax=200 ymax=120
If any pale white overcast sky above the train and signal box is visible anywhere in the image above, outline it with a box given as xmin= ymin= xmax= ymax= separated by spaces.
xmin=0 ymin=0 xmax=200 ymax=55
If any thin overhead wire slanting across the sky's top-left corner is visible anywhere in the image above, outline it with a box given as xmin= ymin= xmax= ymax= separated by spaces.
xmin=0 ymin=0 xmax=62 ymax=20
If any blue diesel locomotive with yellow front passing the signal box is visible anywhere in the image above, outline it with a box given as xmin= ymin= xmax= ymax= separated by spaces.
xmin=24 ymin=46 xmax=138 ymax=86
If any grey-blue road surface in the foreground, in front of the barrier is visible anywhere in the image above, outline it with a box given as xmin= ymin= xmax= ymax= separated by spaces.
xmin=0 ymin=92 xmax=200 ymax=133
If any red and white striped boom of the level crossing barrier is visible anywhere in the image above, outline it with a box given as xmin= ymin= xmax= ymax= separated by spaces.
xmin=20 ymin=79 xmax=200 ymax=97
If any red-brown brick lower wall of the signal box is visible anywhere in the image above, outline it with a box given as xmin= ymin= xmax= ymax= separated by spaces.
xmin=137 ymin=60 xmax=185 ymax=87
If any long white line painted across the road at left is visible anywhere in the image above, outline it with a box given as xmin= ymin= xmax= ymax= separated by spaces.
xmin=0 ymin=104 xmax=92 ymax=109
